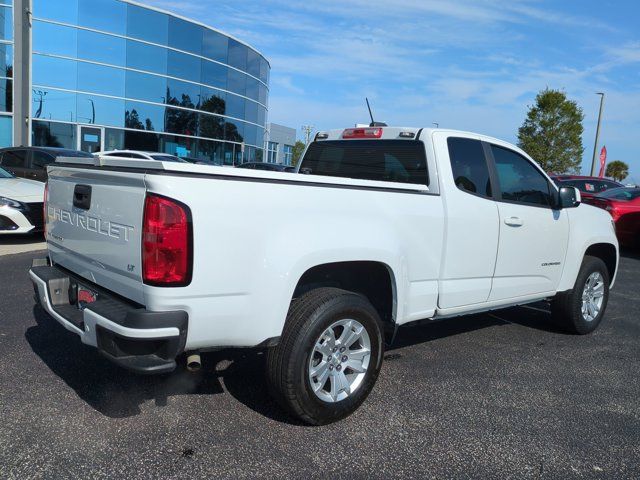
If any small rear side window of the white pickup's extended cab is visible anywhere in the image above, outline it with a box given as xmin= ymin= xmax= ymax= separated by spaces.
xmin=447 ymin=137 xmax=491 ymax=197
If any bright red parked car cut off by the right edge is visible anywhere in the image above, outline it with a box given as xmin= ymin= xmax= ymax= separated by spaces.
xmin=583 ymin=187 xmax=640 ymax=247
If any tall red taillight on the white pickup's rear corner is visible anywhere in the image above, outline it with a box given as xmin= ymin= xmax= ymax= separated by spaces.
xmin=142 ymin=194 xmax=193 ymax=287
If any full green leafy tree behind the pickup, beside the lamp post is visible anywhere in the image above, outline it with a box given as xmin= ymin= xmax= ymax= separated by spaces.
xmin=518 ymin=88 xmax=584 ymax=173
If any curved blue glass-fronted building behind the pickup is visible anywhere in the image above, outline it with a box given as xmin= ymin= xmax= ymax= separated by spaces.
xmin=0 ymin=0 xmax=270 ymax=164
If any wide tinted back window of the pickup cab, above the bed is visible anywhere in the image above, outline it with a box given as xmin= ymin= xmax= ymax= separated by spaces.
xmin=302 ymin=140 xmax=429 ymax=185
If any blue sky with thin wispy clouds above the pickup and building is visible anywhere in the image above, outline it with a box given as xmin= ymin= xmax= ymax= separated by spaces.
xmin=145 ymin=0 xmax=640 ymax=183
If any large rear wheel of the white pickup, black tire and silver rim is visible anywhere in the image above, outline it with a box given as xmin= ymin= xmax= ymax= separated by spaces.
xmin=267 ymin=288 xmax=384 ymax=425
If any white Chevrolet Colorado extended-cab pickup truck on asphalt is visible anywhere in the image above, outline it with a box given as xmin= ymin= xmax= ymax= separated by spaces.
xmin=30 ymin=126 xmax=618 ymax=424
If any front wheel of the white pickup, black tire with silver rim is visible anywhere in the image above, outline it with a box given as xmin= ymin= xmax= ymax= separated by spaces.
xmin=551 ymin=255 xmax=610 ymax=335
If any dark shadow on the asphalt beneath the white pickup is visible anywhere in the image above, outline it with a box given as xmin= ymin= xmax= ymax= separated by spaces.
xmin=25 ymin=304 xmax=559 ymax=425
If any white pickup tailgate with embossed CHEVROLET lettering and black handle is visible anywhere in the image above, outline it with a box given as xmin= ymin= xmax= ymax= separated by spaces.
xmin=46 ymin=167 xmax=146 ymax=304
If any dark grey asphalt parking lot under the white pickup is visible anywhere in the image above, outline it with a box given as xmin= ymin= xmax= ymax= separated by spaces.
xmin=0 ymin=252 xmax=640 ymax=479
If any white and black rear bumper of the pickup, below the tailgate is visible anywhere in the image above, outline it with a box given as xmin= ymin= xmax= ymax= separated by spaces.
xmin=29 ymin=260 xmax=188 ymax=373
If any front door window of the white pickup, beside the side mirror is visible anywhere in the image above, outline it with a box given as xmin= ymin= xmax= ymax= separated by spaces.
xmin=491 ymin=145 xmax=553 ymax=207
